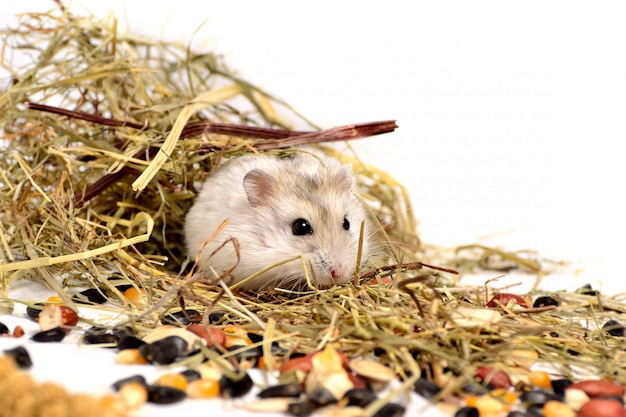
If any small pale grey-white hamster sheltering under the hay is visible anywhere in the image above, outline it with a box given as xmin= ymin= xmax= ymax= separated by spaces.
xmin=185 ymin=150 xmax=371 ymax=290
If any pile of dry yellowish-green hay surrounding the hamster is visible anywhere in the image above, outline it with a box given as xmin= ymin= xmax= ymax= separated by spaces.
xmin=0 ymin=3 xmax=626 ymax=402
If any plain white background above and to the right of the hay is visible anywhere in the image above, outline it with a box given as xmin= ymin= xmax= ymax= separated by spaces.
xmin=0 ymin=0 xmax=626 ymax=415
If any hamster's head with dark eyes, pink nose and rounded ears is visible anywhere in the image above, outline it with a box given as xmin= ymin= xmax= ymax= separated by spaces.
xmin=243 ymin=158 xmax=370 ymax=289
